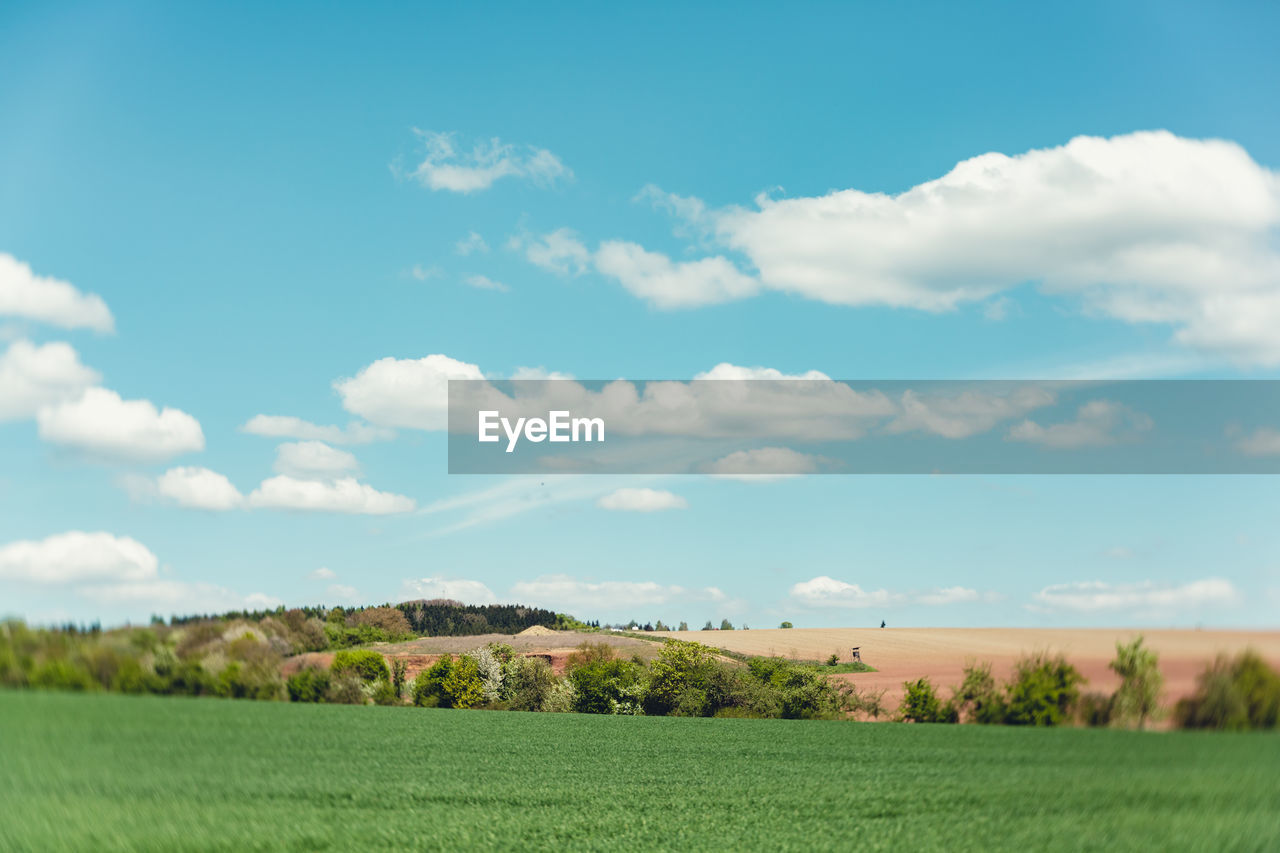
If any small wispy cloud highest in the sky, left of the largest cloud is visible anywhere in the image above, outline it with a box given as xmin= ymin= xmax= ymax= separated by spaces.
xmin=410 ymin=128 xmax=573 ymax=193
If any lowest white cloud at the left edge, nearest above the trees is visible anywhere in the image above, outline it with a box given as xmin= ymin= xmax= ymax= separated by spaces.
xmin=0 ymin=530 xmax=159 ymax=584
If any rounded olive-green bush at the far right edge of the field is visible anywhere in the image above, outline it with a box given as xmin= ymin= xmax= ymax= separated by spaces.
xmin=1174 ymin=651 xmax=1280 ymax=731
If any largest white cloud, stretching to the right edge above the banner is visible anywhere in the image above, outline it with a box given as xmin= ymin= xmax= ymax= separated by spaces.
xmin=640 ymin=131 xmax=1280 ymax=365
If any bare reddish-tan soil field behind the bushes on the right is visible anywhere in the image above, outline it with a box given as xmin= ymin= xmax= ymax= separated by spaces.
xmin=650 ymin=628 xmax=1280 ymax=708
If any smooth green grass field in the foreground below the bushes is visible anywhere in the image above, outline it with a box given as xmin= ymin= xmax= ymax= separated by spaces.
xmin=0 ymin=690 xmax=1280 ymax=850
